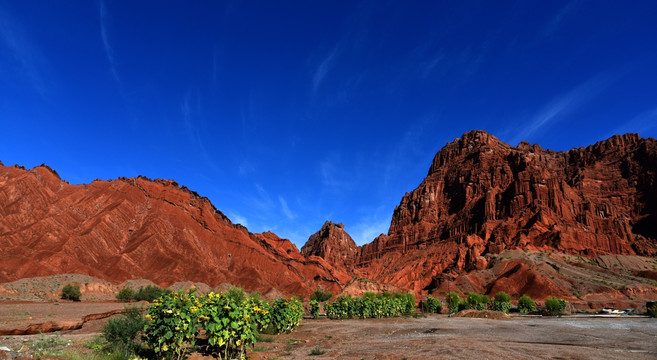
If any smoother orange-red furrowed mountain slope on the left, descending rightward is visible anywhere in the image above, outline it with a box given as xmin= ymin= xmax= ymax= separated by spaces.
xmin=0 ymin=164 xmax=351 ymax=295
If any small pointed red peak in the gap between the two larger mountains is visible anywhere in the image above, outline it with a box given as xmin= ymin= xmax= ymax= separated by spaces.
xmin=301 ymin=221 xmax=358 ymax=269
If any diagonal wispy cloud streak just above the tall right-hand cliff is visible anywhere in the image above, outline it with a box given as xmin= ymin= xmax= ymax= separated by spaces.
xmin=511 ymin=75 xmax=611 ymax=145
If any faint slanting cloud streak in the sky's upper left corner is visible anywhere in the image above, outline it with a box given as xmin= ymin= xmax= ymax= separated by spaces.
xmin=0 ymin=7 xmax=46 ymax=97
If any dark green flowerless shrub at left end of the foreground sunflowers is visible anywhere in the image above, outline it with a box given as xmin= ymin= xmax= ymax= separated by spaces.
xmin=103 ymin=307 xmax=146 ymax=356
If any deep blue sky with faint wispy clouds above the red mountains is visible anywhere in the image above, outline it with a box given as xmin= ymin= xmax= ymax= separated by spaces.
xmin=0 ymin=0 xmax=657 ymax=247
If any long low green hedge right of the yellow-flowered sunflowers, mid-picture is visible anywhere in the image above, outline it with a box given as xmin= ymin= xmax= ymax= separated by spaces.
xmin=324 ymin=292 xmax=415 ymax=319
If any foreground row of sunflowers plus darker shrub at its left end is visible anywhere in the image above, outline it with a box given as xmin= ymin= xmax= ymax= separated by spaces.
xmin=103 ymin=289 xmax=303 ymax=359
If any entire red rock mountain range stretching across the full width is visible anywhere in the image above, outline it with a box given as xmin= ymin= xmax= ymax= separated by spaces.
xmin=0 ymin=131 xmax=657 ymax=304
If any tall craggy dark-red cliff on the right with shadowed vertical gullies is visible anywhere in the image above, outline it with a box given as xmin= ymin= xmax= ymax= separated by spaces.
xmin=356 ymin=131 xmax=657 ymax=290
